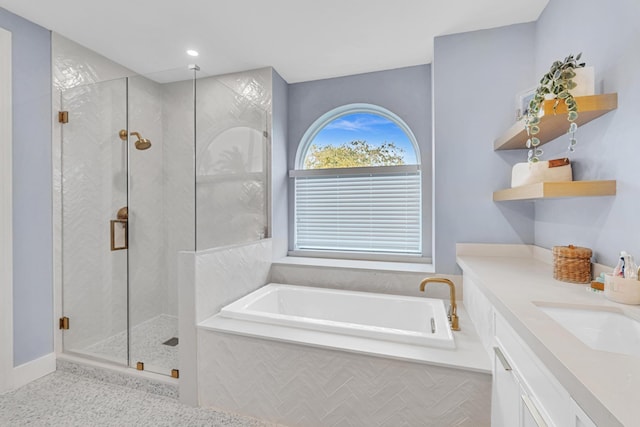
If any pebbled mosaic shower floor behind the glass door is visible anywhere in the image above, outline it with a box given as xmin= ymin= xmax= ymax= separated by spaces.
xmin=81 ymin=314 xmax=179 ymax=375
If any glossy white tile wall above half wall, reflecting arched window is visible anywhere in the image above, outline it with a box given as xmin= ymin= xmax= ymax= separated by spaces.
xmin=196 ymin=68 xmax=271 ymax=250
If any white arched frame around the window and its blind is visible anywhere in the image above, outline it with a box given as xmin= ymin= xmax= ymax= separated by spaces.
xmin=289 ymin=103 xmax=423 ymax=261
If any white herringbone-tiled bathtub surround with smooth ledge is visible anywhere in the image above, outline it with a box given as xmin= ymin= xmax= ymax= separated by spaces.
xmin=197 ymin=285 xmax=491 ymax=427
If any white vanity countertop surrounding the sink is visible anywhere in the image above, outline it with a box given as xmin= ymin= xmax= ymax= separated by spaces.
xmin=457 ymin=249 xmax=640 ymax=427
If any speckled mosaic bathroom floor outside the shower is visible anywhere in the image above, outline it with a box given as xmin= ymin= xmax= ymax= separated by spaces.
xmin=0 ymin=371 xmax=276 ymax=427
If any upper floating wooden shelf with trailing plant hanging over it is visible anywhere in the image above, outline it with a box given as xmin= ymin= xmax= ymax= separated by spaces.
xmin=493 ymin=93 xmax=618 ymax=150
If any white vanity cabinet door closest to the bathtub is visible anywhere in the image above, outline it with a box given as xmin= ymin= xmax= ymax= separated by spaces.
xmin=491 ymin=347 xmax=520 ymax=427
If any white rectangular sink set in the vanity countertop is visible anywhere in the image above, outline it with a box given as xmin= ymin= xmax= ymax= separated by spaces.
xmin=538 ymin=305 xmax=640 ymax=357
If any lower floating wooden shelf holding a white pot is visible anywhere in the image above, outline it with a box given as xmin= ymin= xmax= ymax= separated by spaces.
xmin=493 ymin=180 xmax=616 ymax=202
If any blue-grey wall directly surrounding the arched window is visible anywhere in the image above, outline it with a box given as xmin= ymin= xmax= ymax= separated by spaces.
xmin=288 ymin=65 xmax=431 ymax=257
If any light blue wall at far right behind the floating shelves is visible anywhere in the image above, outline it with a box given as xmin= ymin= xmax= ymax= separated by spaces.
xmin=535 ymin=0 xmax=640 ymax=266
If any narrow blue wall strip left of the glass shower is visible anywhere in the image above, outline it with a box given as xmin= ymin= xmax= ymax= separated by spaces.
xmin=0 ymin=8 xmax=53 ymax=366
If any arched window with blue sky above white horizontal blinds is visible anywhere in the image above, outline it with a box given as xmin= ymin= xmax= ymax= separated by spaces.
xmin=290 ymin=104 xmax=422 ymax=255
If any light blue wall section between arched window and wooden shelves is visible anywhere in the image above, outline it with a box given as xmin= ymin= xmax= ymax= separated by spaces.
xmin=433 ymin=23 xmax=535 ymax=273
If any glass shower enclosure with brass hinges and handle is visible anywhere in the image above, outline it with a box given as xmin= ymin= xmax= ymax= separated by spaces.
xmin=58 ymin=68 xmax=270 ymax=377
